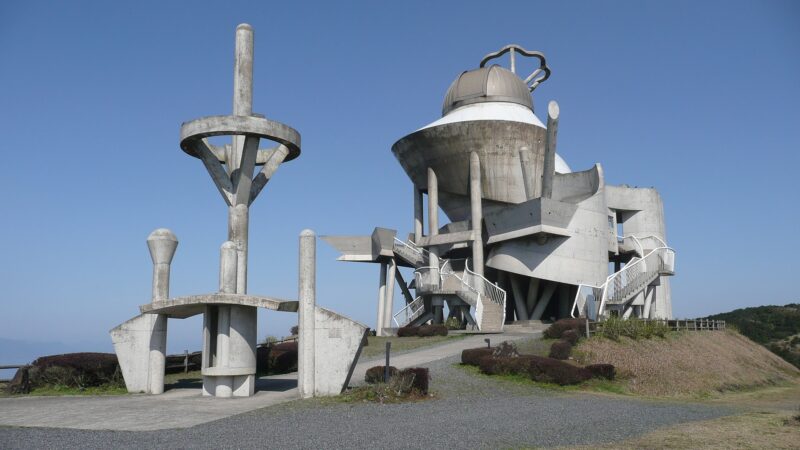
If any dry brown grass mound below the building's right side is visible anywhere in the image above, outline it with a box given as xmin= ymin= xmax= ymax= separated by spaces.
xmin=573 ymin=331 xmax=800 ymax=397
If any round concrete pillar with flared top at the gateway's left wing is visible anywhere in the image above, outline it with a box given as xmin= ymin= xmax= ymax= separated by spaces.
xmin=147 ymin=228 xmax=178 ymax=394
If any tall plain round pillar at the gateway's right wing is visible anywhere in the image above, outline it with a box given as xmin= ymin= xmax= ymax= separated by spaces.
xmin=297 ymin=230 xmax=317 ymax=398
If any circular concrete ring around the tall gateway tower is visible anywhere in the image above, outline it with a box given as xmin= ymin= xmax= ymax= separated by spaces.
xmin=181 ymin=116 xmax=300 ymax=161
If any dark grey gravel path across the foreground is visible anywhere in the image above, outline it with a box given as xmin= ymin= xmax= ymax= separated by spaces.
xmin=0 ymin=346 xmax=736 ymax=449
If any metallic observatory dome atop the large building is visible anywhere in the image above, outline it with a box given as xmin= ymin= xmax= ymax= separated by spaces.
xmin=442 ymin=65 xmax=533 ymax=116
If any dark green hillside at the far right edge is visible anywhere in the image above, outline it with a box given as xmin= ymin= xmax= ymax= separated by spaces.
xmin=708 ymin=303 xmax=800 ymax=367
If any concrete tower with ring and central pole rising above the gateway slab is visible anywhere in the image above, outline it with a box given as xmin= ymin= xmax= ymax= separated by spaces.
xmin=181 ymin=24 xmax=300 ymax=294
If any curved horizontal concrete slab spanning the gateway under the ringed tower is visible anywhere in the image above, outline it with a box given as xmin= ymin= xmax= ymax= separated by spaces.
xmin=139 ymin=293 xmax=298 ymax=319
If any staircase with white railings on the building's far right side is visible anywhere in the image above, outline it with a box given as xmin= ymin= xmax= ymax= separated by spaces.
xmin=572 ymin=236 xmax=675 ymax=320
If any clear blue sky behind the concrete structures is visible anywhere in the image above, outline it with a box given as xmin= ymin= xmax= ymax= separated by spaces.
xmin=0 ymin=0 xmax=800 ymax=364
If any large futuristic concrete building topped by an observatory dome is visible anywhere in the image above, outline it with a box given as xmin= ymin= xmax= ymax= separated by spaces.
xmin=323 ymin=45 xmax=674 ymax=334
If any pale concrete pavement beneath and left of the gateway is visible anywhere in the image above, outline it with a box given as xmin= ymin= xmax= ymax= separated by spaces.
xmin=0 ymin=373 xmax=299 ymax=431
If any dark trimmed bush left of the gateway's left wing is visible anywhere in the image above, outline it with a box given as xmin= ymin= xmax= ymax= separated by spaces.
xmin=28 ymin=353 xmax=123 ymax=388
